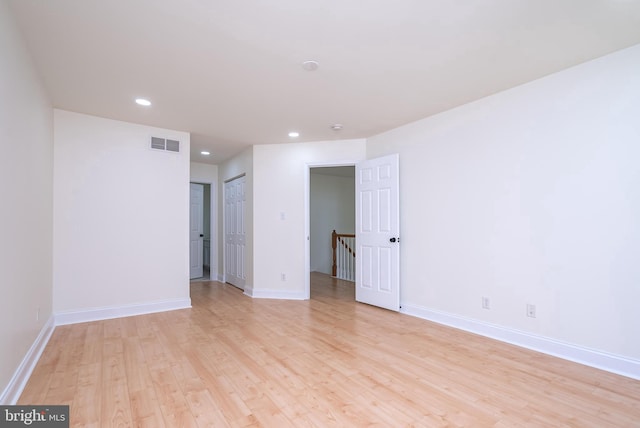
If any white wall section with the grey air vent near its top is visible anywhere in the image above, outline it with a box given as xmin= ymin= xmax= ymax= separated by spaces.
xmin=54 ymin=110 xmax=189 ymax=313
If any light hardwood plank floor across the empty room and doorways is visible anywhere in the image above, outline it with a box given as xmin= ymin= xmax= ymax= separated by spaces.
xmin=20 ymin=274 xmax=640 ymax=428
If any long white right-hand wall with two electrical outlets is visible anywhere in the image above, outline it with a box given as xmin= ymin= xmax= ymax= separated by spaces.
xmin=367 ymin=46 xmax=640 ymax=362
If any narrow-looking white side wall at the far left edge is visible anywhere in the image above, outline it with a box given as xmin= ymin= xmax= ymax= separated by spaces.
xmin=0 ymin=2 xmax=53 ymax=404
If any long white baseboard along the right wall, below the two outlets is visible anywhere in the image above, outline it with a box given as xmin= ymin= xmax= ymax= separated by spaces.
xmin=401 ymin=304 xmax=640 ymax=380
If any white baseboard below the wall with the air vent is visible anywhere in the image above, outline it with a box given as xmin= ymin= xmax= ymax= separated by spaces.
xmin=55 ymin=298 xmax=191 ymax=325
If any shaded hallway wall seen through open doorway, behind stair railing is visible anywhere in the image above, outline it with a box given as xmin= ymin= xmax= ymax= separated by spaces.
xmin=309 ymin=168 xmax=356 ymax=275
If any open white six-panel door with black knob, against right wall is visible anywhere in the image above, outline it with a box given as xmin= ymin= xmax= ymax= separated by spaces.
xmin=356 ymin=154 xmax=400 ymax=311
